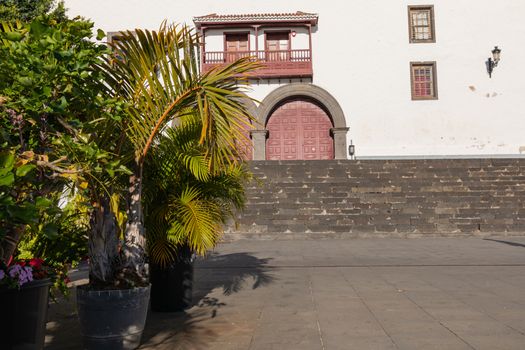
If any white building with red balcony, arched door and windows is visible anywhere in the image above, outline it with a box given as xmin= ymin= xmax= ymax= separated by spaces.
xmin=66 ymin=0 xmax=525 ymax=159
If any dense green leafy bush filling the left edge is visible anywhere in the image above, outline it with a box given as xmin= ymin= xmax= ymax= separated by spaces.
xmin=0 ymin=16 xmax=129 ymax=282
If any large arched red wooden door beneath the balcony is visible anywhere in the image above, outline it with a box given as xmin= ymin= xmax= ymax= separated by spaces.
xmin=266 ymin=99 xmax=334 ymax=160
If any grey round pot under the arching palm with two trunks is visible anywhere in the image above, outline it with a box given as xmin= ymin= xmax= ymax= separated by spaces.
xmin=77 ymin=286 xmax=150 ymax=350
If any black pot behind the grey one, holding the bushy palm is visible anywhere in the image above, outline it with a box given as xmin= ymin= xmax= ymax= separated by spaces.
xmin=150 ymin=247 xmax=194 ymax=312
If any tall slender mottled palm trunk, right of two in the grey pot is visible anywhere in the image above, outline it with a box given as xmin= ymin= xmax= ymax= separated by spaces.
xmin=123 ymin=164 xmax=148 ymax=283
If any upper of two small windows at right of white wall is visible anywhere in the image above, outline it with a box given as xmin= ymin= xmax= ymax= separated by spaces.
xmin=408 ymin=6 xmax=436 ymax=43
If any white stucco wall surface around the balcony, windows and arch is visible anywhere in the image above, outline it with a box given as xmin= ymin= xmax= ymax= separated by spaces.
xmin=66 ymin=0 xmax=525 ymax=156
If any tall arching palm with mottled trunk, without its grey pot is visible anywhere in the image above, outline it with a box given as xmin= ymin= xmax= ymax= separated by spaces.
xmin=96 ymin=23 xmax=258 ymax=283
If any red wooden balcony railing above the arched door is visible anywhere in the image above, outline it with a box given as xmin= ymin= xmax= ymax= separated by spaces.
xmin=202 ymin=49 xmax=313 ymax=78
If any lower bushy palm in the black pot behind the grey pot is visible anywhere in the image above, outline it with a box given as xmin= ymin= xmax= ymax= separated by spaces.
xmin=144 ymin=121 xmax=250 ymax=312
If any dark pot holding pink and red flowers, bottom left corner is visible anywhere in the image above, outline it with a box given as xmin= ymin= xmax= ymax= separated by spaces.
xmin=0 ymin=279 xmax=51 ymax=350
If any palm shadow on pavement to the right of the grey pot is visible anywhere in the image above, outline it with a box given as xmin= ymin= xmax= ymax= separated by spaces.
xmin=141 ymin=253 xmax=274 ymax=349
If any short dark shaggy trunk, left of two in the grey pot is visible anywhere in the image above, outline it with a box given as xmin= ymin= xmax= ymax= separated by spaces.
xmin=88 ymin=195 xmax=119 ymax=284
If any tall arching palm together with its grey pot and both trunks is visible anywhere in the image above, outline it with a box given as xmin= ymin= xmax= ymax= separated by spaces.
xmin=77 ymin=23 xmax=257 ymax=349
